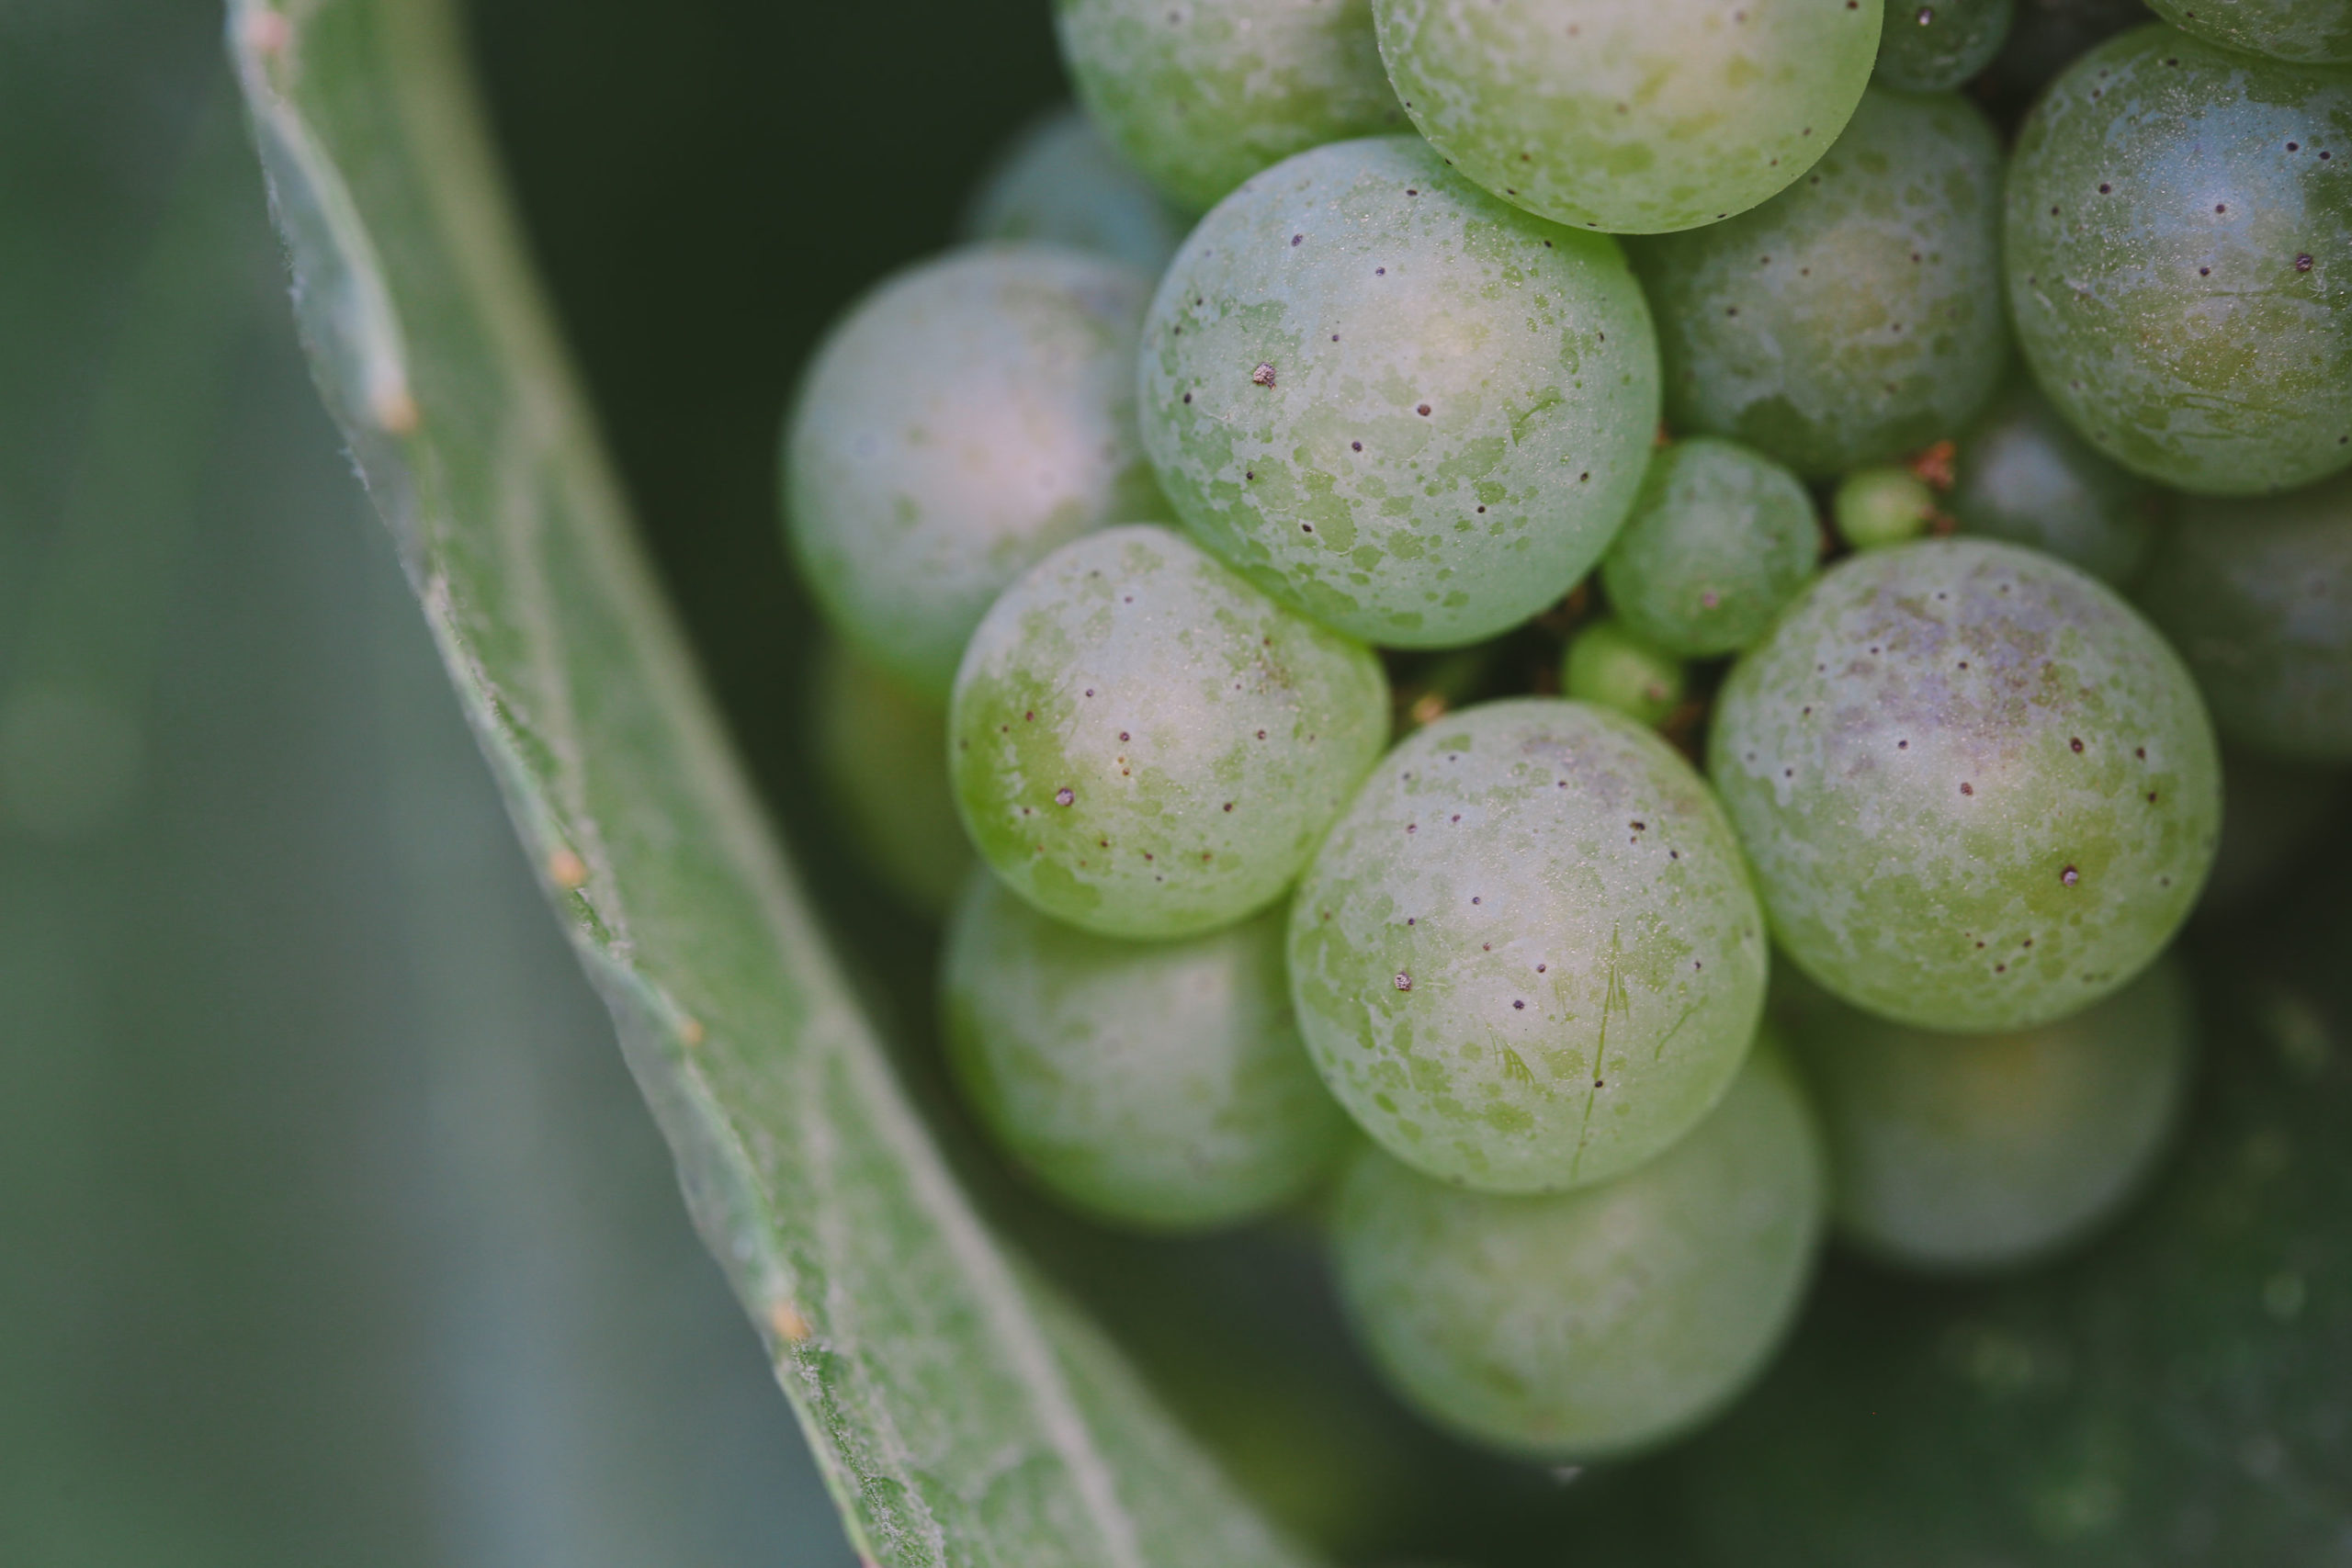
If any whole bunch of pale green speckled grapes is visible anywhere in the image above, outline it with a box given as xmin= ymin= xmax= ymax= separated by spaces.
xmin=783 ymin=0 xmax=2352 ymax=1462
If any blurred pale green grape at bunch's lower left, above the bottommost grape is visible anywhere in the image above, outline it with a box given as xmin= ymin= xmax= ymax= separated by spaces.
xmin=941 ymin=872 xmax=1348 ymax=1229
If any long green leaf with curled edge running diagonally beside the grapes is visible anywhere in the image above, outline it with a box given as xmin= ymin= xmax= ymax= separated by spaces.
xmin=231 ymin=0 xmax=1303 ymax=1568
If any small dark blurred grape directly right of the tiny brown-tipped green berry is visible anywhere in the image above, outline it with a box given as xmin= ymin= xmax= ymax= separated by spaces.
xmin=1950 ymin=381 xmax=2164 ymax=588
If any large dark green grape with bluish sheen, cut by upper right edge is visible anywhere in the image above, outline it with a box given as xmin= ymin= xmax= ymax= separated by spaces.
xmin=2007 ymin=26 xmax=2352 ymax=496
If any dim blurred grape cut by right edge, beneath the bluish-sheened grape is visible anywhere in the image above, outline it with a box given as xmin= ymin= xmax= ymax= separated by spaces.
xmin=2141 ymin=475 xmax=2352 ymax=761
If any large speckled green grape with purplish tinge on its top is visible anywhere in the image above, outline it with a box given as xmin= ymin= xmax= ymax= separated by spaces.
xmin=1708 ymin=538 xmax=2221 ymax=1030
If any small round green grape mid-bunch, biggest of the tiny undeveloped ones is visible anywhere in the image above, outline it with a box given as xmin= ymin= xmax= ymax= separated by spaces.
xmin=1601 ymin=434 xmax=1820 ymax=659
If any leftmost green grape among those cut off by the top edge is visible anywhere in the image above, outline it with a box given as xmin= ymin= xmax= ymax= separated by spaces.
xmin=1054 ymin=0 xmax=1404 ymax=211
